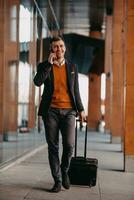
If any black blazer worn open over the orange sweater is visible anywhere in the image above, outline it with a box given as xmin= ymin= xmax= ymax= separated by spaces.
xmin=33 ymin=61 xmax=84 ymax=116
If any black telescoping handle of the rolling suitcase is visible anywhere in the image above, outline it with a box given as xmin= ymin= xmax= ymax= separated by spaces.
xmin=74 ymin=119 xmax=87 ymax=158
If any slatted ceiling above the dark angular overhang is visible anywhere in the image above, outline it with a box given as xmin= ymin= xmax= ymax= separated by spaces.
xmin=21 ymin=0 xmax=113 ymax=36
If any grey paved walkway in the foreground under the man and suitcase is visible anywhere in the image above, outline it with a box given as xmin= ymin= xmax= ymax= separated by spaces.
xmin=0 ymin=145 xmax=134 ymax=200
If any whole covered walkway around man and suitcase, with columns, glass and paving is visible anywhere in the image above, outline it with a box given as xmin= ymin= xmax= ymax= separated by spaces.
xmin=0 ymin=0 xmax=134 ymax=200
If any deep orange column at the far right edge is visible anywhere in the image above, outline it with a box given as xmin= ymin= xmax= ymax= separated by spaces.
xmin=125 ymin=0 xmax=134 ymax=155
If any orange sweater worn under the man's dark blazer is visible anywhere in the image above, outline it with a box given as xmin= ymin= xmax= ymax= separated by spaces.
xmin=51 ymin=64 xmax=72 ymax=108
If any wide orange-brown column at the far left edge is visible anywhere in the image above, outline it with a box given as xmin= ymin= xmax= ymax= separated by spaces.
xmin=0 ymin=0 xmax=19 ymax=140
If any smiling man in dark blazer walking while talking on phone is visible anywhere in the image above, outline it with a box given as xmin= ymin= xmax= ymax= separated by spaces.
xmin=34 ymin=37 xmax=86 ymax=192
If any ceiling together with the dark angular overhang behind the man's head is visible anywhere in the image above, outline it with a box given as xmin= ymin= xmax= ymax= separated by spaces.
xmin=21 ymin=0 xmax=113 ymax=75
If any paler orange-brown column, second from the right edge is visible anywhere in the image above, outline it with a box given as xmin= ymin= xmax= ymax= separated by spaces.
xmin=111 ymin=0 xmax=126 ymax=139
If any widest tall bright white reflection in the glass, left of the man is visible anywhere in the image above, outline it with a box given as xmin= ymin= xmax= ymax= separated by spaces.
xmin=18 ymin=5 xmax=32 ymax=130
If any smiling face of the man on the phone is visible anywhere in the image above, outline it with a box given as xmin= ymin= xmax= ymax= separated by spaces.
xmin=52 ymin=40 xmax=66 ymax=59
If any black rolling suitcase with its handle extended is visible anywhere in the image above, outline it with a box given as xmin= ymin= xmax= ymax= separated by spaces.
xmin=68 ymin=120 xmax=98 ymax=187
